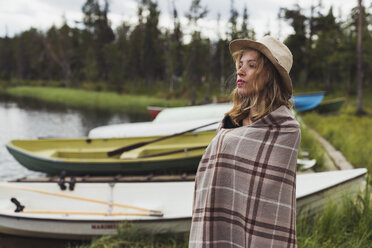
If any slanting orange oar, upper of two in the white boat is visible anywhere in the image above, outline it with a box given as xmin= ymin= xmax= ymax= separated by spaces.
xmin=0 ymin=183 xmax=163 ymax=216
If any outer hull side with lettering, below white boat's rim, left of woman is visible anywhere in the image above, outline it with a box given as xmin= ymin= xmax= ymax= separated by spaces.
xmin=0 ymin=214 xmax=191 ymax=240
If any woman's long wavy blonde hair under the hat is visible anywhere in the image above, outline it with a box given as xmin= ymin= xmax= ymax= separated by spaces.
xmin=226 ymin=49 xmax=293 ymax=126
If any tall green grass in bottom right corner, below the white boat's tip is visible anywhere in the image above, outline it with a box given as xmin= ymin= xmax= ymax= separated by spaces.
xmin=297 ymin=184 xmax=372 ymax=248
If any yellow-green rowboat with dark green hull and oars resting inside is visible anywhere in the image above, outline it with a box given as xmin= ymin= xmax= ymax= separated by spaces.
xmin=6 ymin=131 xmax=215 ymax=175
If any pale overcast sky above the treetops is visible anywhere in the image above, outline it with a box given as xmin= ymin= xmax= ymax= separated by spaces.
xmin=0 ymin=0 xmax=372 ymax=39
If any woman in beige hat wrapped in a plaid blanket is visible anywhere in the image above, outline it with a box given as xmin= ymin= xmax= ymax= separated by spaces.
xmin=189 ymin=36 xmax=301 ymax=248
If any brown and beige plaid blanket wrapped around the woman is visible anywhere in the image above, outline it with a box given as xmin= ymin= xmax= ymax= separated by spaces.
xmin=189 ymin=106 xmax=301 ymax=248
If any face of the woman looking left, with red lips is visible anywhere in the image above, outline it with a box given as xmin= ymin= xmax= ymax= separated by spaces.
xmin=236 ymin=50 xmax=264 ymax=96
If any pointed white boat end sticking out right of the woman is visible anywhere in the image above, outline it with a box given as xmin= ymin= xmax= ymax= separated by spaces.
xmin=296 ymin=168 xmax=367 ymax=216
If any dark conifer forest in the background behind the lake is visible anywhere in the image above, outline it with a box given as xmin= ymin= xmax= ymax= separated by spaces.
xmin=0 ymin=0 xmax=372 ymax=103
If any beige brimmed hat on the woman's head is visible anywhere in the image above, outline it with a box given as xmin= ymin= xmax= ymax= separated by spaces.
xmin=229 ymin=36 xmax=293 ymax=95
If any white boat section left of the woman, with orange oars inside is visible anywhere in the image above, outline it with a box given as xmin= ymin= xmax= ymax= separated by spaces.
xmin=0 ymin=181 xmax=194 ymax=239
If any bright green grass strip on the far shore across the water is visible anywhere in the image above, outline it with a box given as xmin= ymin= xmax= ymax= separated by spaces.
xmin=1 ymin=86 xmax=188 ymax=114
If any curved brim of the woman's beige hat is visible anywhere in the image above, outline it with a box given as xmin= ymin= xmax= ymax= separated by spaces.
xmin=229 ymin=39 xmax=293 ymax=95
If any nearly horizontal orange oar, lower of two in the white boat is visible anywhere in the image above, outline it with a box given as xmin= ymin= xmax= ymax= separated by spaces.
xmin=0 ymin=210 xmax=161 ymax=217
